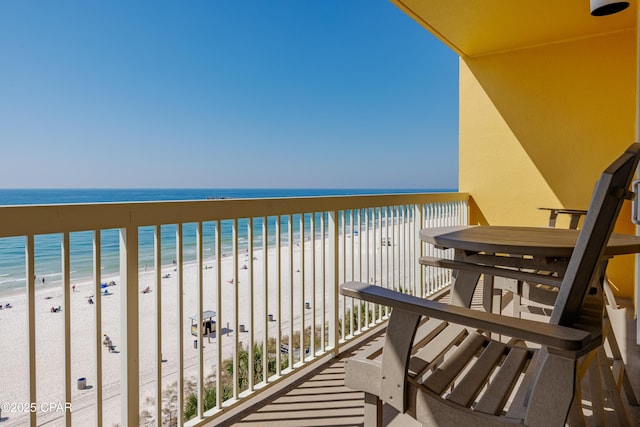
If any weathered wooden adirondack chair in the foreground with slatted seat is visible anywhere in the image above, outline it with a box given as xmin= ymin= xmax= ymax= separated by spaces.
xmin=340 ymin=143 xmax=640 ymax=427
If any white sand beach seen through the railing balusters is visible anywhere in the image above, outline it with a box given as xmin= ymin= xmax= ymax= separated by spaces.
xmin=0 ymin=236 xmax=392 ymax=426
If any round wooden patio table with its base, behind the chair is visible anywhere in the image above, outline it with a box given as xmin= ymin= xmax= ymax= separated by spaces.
xmin=420 ymin=226 xmax=640 ymax=311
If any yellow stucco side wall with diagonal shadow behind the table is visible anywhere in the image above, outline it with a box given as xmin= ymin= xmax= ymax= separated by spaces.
xmin=459 ymin=31 xmax=637 ymax=297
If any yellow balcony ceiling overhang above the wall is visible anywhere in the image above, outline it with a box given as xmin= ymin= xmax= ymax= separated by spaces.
xmin=391 ymin=0 xmax=637 ymax=57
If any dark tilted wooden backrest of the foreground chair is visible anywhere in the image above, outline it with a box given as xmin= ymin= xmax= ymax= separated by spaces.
xmin=550 ymin=143 xmax=640 ymax=325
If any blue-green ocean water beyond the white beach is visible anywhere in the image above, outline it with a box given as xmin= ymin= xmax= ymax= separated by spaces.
xmin=0 ymin=189 xmax=448 ymax=293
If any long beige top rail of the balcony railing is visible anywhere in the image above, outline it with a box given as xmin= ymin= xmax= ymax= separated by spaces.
xmin=0 ymin=192 xmax=469 ymax=237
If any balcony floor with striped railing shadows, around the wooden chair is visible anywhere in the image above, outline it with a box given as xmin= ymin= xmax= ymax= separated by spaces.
xmin=225 ymin=284 xmax=640 ymax=427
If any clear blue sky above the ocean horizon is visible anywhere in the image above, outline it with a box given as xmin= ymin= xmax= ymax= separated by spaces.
xmin=0 ymin=0 xmax=458 ymax=188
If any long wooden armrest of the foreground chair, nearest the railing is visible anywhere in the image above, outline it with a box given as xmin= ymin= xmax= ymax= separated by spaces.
xmin=340 ymin=282 xmax=602 ymax=357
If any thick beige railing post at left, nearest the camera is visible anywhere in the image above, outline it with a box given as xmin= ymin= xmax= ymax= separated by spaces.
xmin=121 ymin=226 xmax=140 ymax=426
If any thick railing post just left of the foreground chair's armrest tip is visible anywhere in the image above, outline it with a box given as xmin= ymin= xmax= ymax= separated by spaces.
xmin=327 ymin=211 xmax=340 ymax=357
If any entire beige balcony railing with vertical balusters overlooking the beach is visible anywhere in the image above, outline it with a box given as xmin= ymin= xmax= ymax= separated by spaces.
xmin=0 ymin=193 xmax=468 ymax=426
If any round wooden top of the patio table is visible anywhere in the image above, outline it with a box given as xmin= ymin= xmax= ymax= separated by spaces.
xmin=420 ymin=225 xmax=640 ymax=258
